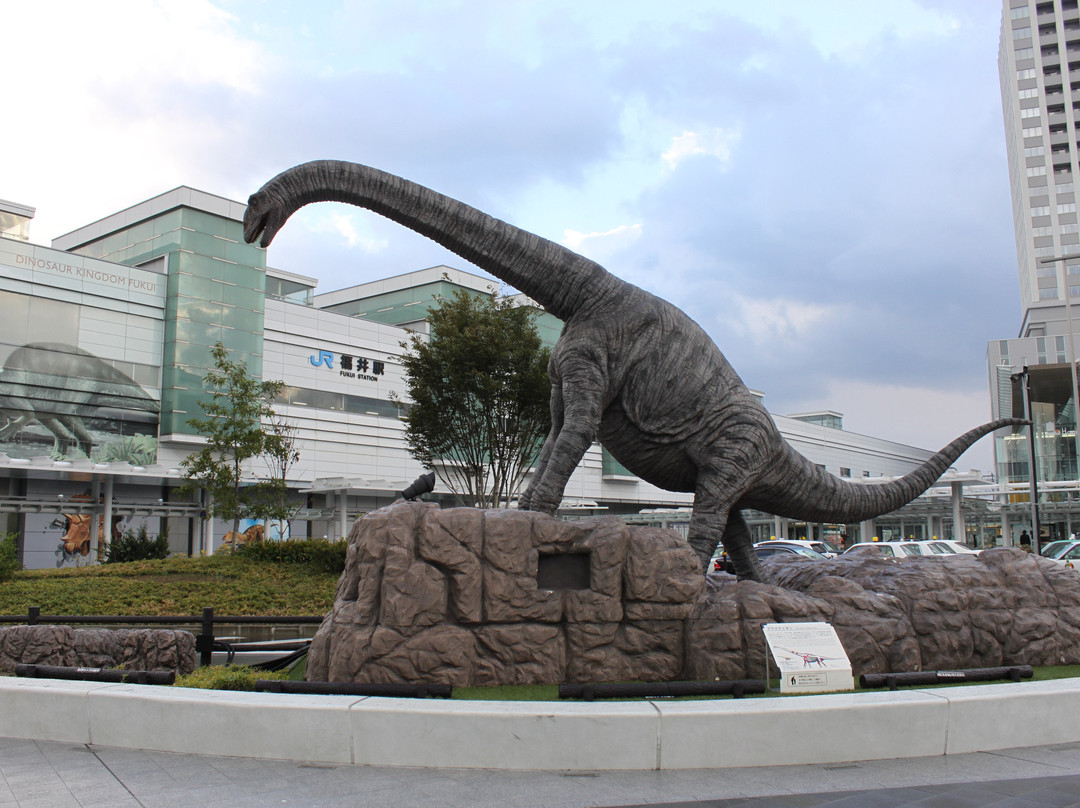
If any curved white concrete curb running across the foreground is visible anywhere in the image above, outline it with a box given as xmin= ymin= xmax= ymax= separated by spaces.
xmin=0 ymin=677 xmax=1080 ymax=771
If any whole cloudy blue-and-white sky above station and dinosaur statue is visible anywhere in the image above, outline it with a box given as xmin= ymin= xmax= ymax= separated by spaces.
xmin=0 ymin=0 xmax=1021 ymax=471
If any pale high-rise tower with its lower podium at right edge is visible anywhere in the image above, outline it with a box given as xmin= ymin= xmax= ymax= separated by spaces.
xmin=987 ymin=0 xmax=1080 ymax=518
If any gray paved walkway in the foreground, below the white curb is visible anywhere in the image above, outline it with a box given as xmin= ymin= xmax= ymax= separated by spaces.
xmin=6 ymin=739 xmax=1080 ymax=808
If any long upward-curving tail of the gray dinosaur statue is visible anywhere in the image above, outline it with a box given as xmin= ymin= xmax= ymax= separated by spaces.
xmin=747 ymin=418 xmax=1027 ymax=523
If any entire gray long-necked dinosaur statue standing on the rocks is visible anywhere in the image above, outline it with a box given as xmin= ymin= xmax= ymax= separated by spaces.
xmin=244 ymin=160 xmax=1022 ymax=580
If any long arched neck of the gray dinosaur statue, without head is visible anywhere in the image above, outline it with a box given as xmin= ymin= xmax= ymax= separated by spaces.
xmin=267 ymin=160 xmax=623 ymax=320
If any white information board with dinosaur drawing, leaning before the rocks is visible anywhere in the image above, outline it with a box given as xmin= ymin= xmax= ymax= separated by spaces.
xmin=761 ymin=623 xmax=855 ymax=693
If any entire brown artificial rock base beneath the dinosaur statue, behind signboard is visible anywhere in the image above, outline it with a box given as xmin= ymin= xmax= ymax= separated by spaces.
xmin=308 ymin=502 xmax=1080 ymax=686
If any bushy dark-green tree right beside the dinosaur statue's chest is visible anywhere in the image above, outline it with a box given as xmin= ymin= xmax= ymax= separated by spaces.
xmin=402 ymin=291 xmax=551 ymax=508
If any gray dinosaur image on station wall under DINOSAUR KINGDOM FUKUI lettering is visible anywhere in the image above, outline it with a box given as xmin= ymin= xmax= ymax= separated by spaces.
xmin=0 ymin=342 xmax=159 ymax=457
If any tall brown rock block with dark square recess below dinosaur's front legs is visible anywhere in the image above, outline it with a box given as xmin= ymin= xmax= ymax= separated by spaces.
xmin=307 ymin=502 xmax=704 ymax=686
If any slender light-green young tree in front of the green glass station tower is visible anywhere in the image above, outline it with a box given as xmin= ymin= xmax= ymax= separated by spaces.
xmin=180 ymin=342 xmax=284 ymax=542
